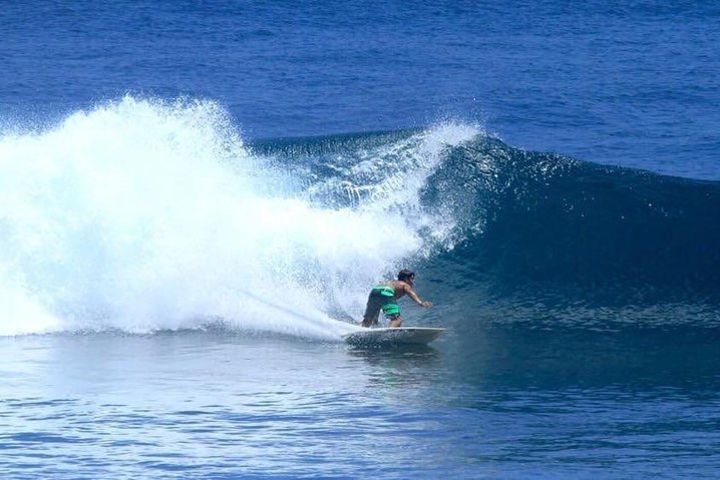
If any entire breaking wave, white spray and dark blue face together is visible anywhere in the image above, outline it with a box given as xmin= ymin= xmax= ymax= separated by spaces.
xmin=0 ymin=97 xmax=720 ymax=339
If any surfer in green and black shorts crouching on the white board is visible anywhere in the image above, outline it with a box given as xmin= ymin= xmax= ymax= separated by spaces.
xmin=361 ymin=269 xmax=432 ymax=327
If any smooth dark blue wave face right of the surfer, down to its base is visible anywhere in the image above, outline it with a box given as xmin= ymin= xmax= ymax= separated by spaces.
xmin=416 ymin=138 xmax=720 ymax=327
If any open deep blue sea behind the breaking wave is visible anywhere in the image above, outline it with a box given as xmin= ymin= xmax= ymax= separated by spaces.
xmin=0 ymin=1 xmax=720 ymax=179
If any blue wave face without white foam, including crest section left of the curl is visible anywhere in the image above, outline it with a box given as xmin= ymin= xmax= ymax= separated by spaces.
xmin=262 ymin=125 xmax=720 ymax=328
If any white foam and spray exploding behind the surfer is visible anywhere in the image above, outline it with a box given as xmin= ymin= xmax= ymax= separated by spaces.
xmin=0 ymin=97 xmax=484 ymax=338
